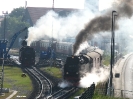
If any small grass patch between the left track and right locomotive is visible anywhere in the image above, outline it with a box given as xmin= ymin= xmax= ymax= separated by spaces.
xmin=41 ymin=67 xmax=62 ymax=78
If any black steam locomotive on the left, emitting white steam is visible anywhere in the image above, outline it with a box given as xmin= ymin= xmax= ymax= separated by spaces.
xmin=19 ymin=40 xmax=35 ymax=67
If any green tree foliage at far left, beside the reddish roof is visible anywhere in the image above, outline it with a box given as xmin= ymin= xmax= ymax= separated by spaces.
xmin=0 ymin=7 xmax=29 ymax=46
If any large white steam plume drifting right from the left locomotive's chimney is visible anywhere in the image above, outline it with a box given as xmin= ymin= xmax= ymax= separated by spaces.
xmin=27 ymin=10 xmax=94 ymax=45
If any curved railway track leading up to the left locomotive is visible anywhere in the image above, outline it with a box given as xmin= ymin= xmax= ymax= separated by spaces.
xmin=25 ymin=67 xmax=52 ymax=99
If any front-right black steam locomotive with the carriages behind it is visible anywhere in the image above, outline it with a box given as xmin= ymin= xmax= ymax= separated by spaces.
xmin=63 ymin=49 xmax=103 ymax=86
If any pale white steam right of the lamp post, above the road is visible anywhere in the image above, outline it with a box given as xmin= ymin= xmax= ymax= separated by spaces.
xmin=115 ymin=16 xmax=133 ymax=53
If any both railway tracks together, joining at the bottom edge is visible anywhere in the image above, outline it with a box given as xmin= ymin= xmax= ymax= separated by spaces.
xmin=25 ymin=67 xmax=78 ymax=99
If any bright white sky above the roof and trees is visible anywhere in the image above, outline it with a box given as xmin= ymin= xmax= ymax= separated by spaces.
xmin=0 ymin=0 xmax=116 ymax=15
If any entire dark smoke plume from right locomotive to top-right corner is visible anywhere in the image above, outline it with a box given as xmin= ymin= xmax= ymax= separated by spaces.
xmin=73 ymin=0 xmax=133 ymax=54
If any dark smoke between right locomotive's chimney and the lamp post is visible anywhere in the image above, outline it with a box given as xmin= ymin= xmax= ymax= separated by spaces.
xmin=73 ymin=16 xmax=111 ymax=53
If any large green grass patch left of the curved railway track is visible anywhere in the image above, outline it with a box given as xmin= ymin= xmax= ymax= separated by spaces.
xmin=4 ymin=66 xmax=32 ymax=90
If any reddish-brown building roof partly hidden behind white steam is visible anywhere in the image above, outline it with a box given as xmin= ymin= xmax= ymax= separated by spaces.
xmin=25 ymin=7 xmax=78 ymax=25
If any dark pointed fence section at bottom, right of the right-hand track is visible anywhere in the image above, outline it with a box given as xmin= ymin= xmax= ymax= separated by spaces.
xmin=79 ymin=83 xmax=95 ymax=99
